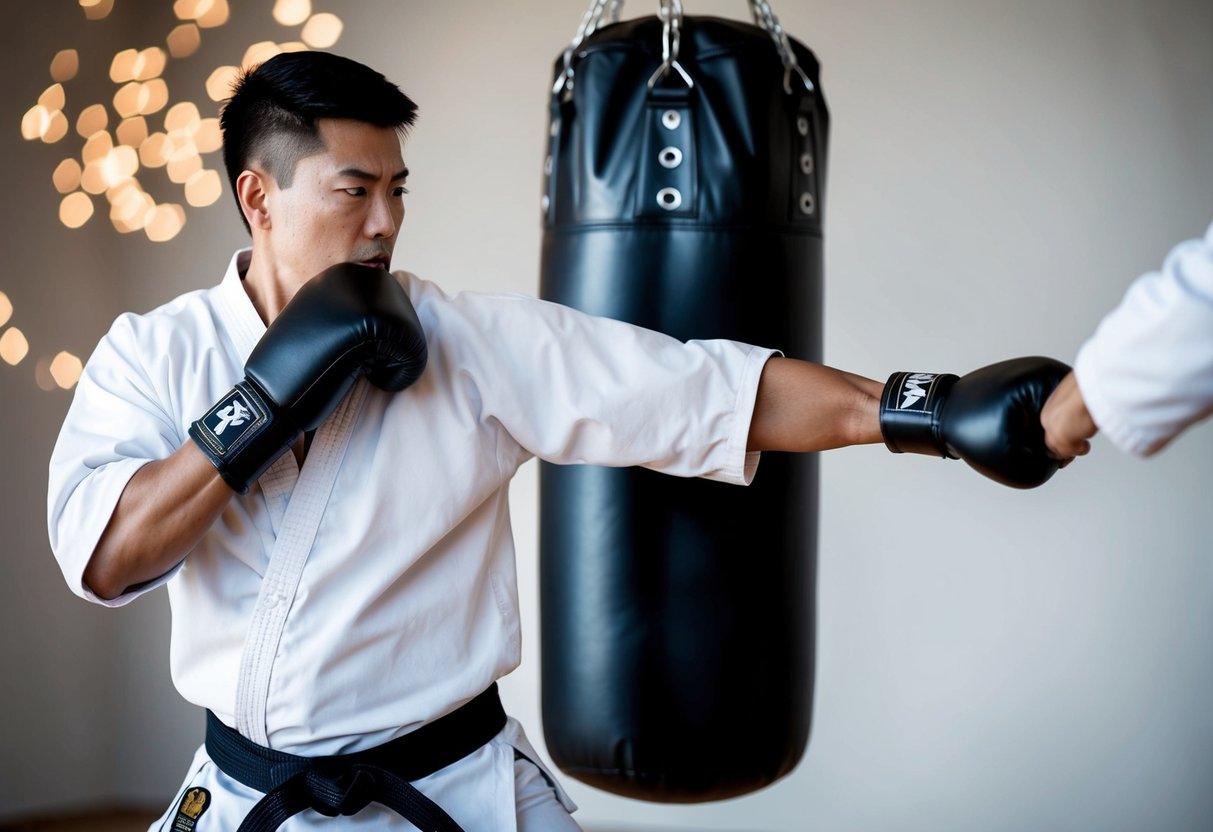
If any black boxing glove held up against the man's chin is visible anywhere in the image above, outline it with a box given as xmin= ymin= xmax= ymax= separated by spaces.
xmin=189 ymin=263 xmax=427 ymax=494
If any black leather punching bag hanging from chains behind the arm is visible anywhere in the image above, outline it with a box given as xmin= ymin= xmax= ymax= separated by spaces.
xmin=540 ymin=0 xmax=827 ymax=803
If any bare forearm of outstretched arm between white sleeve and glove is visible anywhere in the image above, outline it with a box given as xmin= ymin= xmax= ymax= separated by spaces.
xmin=748 ymin=358 xmax=884 ymax=452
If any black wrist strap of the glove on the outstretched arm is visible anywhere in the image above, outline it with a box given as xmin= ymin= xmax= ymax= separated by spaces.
xmin=881 ymin=372 xmax=958 ymax=460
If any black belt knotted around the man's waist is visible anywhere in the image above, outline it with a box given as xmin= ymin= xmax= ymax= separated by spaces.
xmin=206 ymin=683 xmax=506 ymax=832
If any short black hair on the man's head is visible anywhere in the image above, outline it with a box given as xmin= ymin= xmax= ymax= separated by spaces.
xmin=220 ymin=52 xmax=417 ymax=229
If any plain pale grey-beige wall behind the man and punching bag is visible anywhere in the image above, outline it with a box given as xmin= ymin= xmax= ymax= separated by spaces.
xmin=0 ymin=0 xmax=1213 ymax=832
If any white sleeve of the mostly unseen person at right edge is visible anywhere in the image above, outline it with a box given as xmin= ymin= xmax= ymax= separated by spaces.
xmin=1075 ymin=226 xmax=1213 ymax=456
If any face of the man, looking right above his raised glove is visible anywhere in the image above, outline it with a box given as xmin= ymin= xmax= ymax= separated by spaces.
xmin=264 ymin=119 xmax=408 ymax=281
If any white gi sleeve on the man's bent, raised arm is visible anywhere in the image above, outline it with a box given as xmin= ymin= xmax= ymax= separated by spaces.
xmin=47 ymin=315 xmax=182 ymax=606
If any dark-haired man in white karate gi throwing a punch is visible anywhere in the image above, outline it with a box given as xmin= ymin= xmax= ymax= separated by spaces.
xmin=49 ymin=52 xmax=1060 ymax=831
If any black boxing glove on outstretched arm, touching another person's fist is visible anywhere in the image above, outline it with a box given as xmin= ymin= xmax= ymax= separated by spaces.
xmin=881 ymin=357 xmax=1070 ymax=489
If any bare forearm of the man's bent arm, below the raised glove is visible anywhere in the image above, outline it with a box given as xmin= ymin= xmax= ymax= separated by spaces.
xmin=84 ymin=441 xmax=234 ymax=600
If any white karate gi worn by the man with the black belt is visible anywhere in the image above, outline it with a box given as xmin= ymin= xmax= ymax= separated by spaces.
xmin=49 ymin=251 xmax=773 ymax=832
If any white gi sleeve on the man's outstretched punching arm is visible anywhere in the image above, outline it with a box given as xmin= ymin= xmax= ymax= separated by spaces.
xmin=436 ymin=296 xmax=775 ymax=484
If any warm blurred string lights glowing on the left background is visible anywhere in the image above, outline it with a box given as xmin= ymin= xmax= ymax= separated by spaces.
xmin=16 ymin=0 xmax=344 ymax=391
